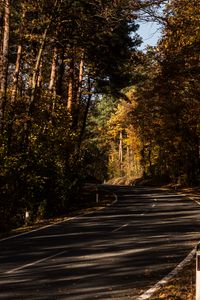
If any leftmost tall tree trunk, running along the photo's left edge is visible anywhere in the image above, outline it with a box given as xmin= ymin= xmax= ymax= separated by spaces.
xmin=0 ymin=0 xmax=10 ymax=128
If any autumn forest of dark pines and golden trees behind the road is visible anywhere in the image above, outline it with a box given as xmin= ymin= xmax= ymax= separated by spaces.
xmin=0 ymin=0 xmax=200 ymax=232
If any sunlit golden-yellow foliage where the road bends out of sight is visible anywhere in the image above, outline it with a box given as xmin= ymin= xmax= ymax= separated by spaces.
xmin=96 ymin=87 xmax=142 ymax=178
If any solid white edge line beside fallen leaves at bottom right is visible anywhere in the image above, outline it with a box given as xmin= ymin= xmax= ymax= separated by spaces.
xmin=137 ymin=247 xmax=196 ymax=300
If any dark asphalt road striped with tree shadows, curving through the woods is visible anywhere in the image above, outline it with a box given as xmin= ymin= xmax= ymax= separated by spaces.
xmin=0 ymin=187 xmax=200 ymax=300
